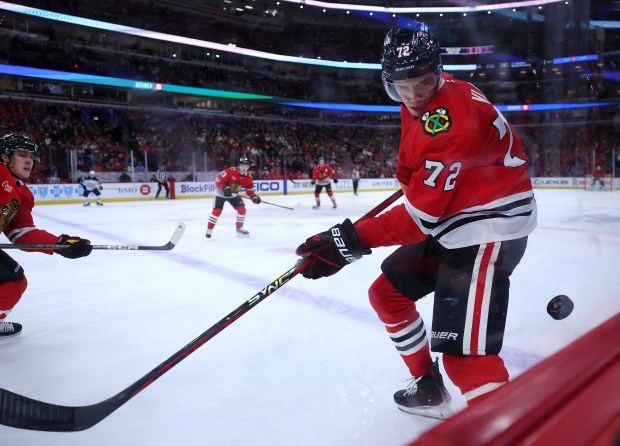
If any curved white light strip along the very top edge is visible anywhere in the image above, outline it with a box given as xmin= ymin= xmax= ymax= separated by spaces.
xmin=282 ymin=0 xmax=564 ymax=14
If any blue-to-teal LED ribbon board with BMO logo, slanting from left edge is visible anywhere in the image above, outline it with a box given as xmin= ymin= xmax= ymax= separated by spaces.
xmin=0 ymin=64 xmax=274 ymax=101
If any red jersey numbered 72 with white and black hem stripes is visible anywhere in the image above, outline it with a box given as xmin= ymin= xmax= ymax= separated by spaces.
xmin=356 ymin=73 xmax=536 ymax=249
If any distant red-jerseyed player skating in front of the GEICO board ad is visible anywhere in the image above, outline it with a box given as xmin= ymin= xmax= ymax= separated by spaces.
xmin=206 ymin=157 xmax=261 ymax=238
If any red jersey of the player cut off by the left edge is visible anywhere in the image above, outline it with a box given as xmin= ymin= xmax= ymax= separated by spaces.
xmin=0 ymin=164 xmax=58 ymax=254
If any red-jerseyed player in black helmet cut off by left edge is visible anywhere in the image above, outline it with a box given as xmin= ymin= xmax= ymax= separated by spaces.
xmin=0 ymin=133 xmax=92 ymax=339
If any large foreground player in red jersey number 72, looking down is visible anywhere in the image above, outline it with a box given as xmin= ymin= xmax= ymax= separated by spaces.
xmin=296 ymin=23 xmax=536 ymax=418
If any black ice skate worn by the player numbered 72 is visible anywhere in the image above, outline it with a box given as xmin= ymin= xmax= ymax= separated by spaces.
xmin=394 ymin=359 xmax=452 ymax=419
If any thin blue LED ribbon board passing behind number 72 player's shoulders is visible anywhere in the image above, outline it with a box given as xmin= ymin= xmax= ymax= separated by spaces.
xmin=275 ymin=101 xmax=618 ymax=113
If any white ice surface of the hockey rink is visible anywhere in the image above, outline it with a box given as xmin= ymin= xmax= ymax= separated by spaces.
xmin=0 ymin=190 xmax=620 ymax=446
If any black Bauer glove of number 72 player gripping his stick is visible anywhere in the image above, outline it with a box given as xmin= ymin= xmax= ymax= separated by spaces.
xmin=295 ymin=218 xmax=372 ymax=279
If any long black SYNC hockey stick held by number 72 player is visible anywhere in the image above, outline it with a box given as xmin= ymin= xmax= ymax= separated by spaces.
xmin=0 ymin=189 xmax=403 ymax=432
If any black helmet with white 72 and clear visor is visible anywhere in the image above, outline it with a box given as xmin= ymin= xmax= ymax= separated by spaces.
xmin=381 ymin=22 xmax=442 ymax=102
